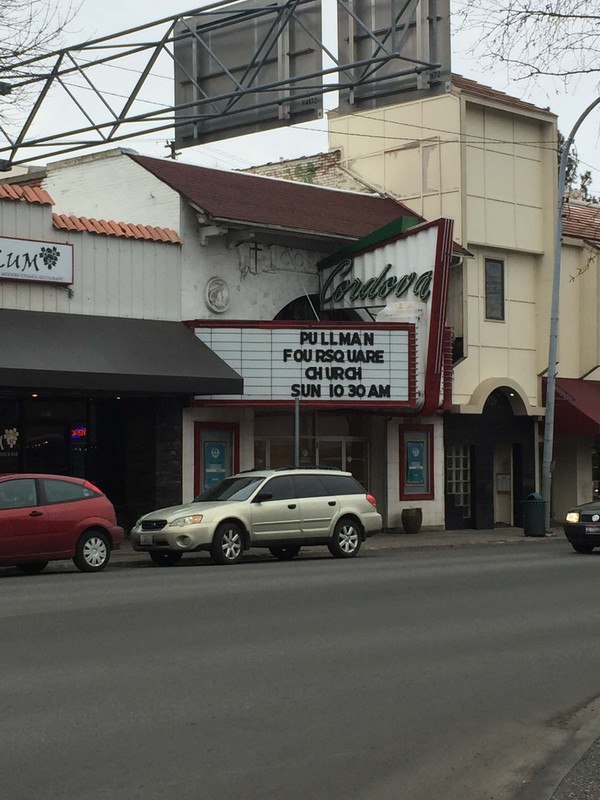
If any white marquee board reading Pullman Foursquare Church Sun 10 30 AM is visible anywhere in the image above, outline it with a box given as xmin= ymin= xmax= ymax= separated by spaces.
xmin=195 ymin=322 xmax=415 ymax=407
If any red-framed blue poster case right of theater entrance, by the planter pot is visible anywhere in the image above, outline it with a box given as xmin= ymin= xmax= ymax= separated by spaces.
xmin=400 ymin=425 xmax=433 ymax=500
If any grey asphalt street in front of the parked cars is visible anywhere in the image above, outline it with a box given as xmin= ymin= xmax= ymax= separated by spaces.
xmin=0 ymin=531 xmax=600 ymax=800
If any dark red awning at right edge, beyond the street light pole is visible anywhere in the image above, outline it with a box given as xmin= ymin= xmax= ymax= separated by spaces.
xmin=554 ymin=378 xmax=600 ymax=435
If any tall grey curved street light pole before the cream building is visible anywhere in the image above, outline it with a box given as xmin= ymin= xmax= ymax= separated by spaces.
xmin=542 ymin=97 xmax=600 ymax=531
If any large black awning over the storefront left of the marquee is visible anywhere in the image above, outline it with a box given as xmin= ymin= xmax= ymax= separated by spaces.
xmin=0 ymin=309 xmax=243 ymax=395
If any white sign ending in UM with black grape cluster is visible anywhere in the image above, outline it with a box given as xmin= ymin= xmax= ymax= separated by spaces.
xmin=0 ymin=236 xmax=73 ymax=284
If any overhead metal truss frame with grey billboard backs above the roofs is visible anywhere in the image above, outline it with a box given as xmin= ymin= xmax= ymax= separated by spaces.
xmin=0 ymin=0 xmax=450 ymax=170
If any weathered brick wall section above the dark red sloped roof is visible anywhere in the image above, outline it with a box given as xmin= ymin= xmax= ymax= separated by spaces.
xmin=243 ymin=150 xmax=372 ymax=193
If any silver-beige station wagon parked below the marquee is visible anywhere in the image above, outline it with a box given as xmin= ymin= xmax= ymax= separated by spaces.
xmin=130 ymin=469 xmax=382 ymax=566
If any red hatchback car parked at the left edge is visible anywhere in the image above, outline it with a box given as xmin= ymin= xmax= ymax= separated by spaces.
xmin=0 ymin=475 xmax=123 ymax=575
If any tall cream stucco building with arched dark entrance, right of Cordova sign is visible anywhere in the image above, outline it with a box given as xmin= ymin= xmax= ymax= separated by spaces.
xmin=251 ymin=76 xmax=557 ymax=528
